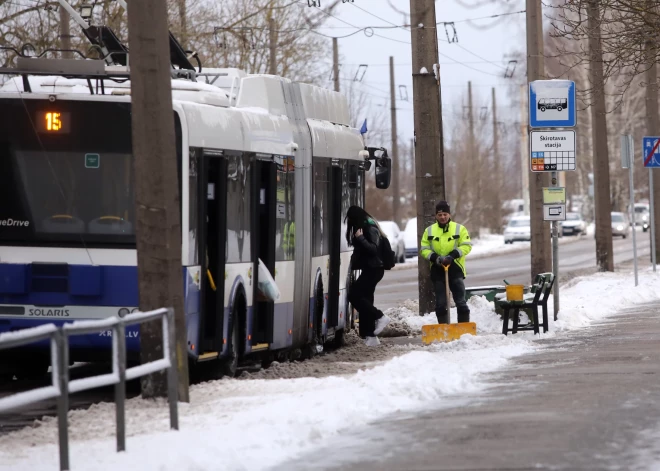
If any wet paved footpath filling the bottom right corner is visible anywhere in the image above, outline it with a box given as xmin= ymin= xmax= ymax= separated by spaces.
xmin=281 ymin=304 xmax=660 ymax=471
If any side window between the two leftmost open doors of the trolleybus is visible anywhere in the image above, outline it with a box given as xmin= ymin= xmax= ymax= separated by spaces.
xmin=226 ymin=153 xmax=252 ymax=263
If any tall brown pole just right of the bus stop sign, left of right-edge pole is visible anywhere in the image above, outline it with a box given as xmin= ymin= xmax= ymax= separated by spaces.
xmin=587 ymin=0 xmax=614 ymax=271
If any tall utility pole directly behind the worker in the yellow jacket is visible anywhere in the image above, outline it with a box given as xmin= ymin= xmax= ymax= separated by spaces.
xmin=410 ymin=0 xmax=451 ymax=313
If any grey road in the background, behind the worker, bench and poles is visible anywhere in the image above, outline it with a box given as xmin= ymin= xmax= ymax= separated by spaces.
xmin=375 ymin=231 xmax=650 ymax=309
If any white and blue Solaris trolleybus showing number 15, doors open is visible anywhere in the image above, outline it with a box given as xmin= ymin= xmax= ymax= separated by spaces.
xmin=0 ymin=57 xmax=391 ymax=374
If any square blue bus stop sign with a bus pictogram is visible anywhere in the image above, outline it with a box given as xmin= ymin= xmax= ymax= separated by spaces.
xmin=529 ymin=80 xmax=576 ymax=128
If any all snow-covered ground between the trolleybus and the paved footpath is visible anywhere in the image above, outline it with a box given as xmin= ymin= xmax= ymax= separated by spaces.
xmin=0 ymin=271 xmax=660 ymax=471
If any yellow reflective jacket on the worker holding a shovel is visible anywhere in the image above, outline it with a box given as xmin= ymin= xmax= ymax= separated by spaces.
xmin=419 ymin=221 xmax=472 ymax=276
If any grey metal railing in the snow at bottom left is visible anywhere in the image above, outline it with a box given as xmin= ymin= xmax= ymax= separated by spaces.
xmin=0 ymin=308 xmax=179 ymax=471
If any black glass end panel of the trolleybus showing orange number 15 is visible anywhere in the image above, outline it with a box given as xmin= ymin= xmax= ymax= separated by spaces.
xmin=0 ymin=99 xmax=150 ymax=247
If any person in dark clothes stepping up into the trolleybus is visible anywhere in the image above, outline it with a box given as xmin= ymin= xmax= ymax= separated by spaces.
xmin=345 ymin=206 xmax=391 ymax=347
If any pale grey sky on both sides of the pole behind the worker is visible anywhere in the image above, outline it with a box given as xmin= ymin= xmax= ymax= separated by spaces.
xmin=314 ymin=0 xmax=525 ymax=143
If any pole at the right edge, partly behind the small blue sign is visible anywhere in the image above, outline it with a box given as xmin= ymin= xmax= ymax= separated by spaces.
xmin=645 ymin=0 xmax=660 ymax=260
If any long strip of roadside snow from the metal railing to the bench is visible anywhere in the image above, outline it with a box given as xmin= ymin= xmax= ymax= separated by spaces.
xmin=0 ymin=336 xmax=532 ymax=471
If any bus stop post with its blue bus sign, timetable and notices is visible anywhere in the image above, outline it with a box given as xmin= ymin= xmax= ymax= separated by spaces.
xmin=529 ymin=80 xmax=577 ymax=321
